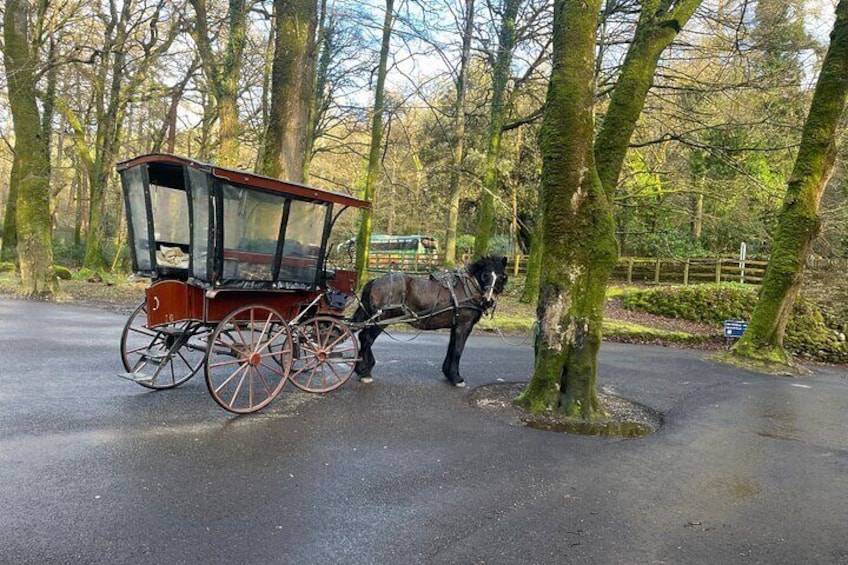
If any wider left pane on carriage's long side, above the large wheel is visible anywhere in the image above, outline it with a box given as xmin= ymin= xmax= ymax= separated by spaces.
xmin=223 ymin=184 xmax=285 ymax=281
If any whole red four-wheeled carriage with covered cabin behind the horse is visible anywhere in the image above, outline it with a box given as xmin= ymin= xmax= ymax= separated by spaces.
xmin=118 ymin=155 xmax=369 ymax=413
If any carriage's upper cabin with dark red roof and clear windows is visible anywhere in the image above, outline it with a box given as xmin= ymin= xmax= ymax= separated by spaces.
xmin=118 ymin=154 xmax=370 ymax=290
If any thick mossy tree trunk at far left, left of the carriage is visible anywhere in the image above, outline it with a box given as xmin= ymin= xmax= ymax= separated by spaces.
xmin=3 ymin=0 xmax=59 ymax=299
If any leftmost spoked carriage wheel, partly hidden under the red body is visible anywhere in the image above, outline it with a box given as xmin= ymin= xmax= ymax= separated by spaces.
xmin=121 ymin=302 xmax=206 ymax=390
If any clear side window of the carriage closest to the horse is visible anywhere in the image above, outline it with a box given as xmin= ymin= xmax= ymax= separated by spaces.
xmin=280 ymin=200 xmax=328 ymax=284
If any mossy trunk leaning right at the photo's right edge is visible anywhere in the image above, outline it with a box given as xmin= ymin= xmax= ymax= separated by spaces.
xmin=734 ymin=0 xmax=848 ymax=363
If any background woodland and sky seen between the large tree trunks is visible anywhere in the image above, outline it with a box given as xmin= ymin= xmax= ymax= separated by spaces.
xmin=0 ymin=0 xmax=848 ymax=270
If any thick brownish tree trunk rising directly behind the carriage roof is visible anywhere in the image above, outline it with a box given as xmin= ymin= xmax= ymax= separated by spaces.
xmin=259 ymin=0 xmax=318 ymax=182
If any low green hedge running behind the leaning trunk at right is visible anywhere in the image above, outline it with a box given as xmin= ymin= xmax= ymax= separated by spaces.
xmin=622 ymin=284 xmax=848 ymax=362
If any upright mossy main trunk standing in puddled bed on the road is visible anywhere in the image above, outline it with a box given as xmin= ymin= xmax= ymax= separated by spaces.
xmin=519 ymin=0 xmax=617 ymax=420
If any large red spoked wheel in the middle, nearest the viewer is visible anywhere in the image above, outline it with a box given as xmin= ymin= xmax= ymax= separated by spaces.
xmin=206 ymin=304 xmax=292 ymax=414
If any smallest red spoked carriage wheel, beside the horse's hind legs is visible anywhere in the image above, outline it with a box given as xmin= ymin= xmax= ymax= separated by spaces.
xmin=289 ymin=316 xmax=359 ymax=392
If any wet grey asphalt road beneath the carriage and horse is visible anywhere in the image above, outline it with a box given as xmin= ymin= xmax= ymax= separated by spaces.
xmin=0 ymin=299 xmax=848 ymax=564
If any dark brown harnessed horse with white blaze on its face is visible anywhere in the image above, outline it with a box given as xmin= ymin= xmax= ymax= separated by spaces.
xmin=353 ymin=256 xmax=507 ymax=387
